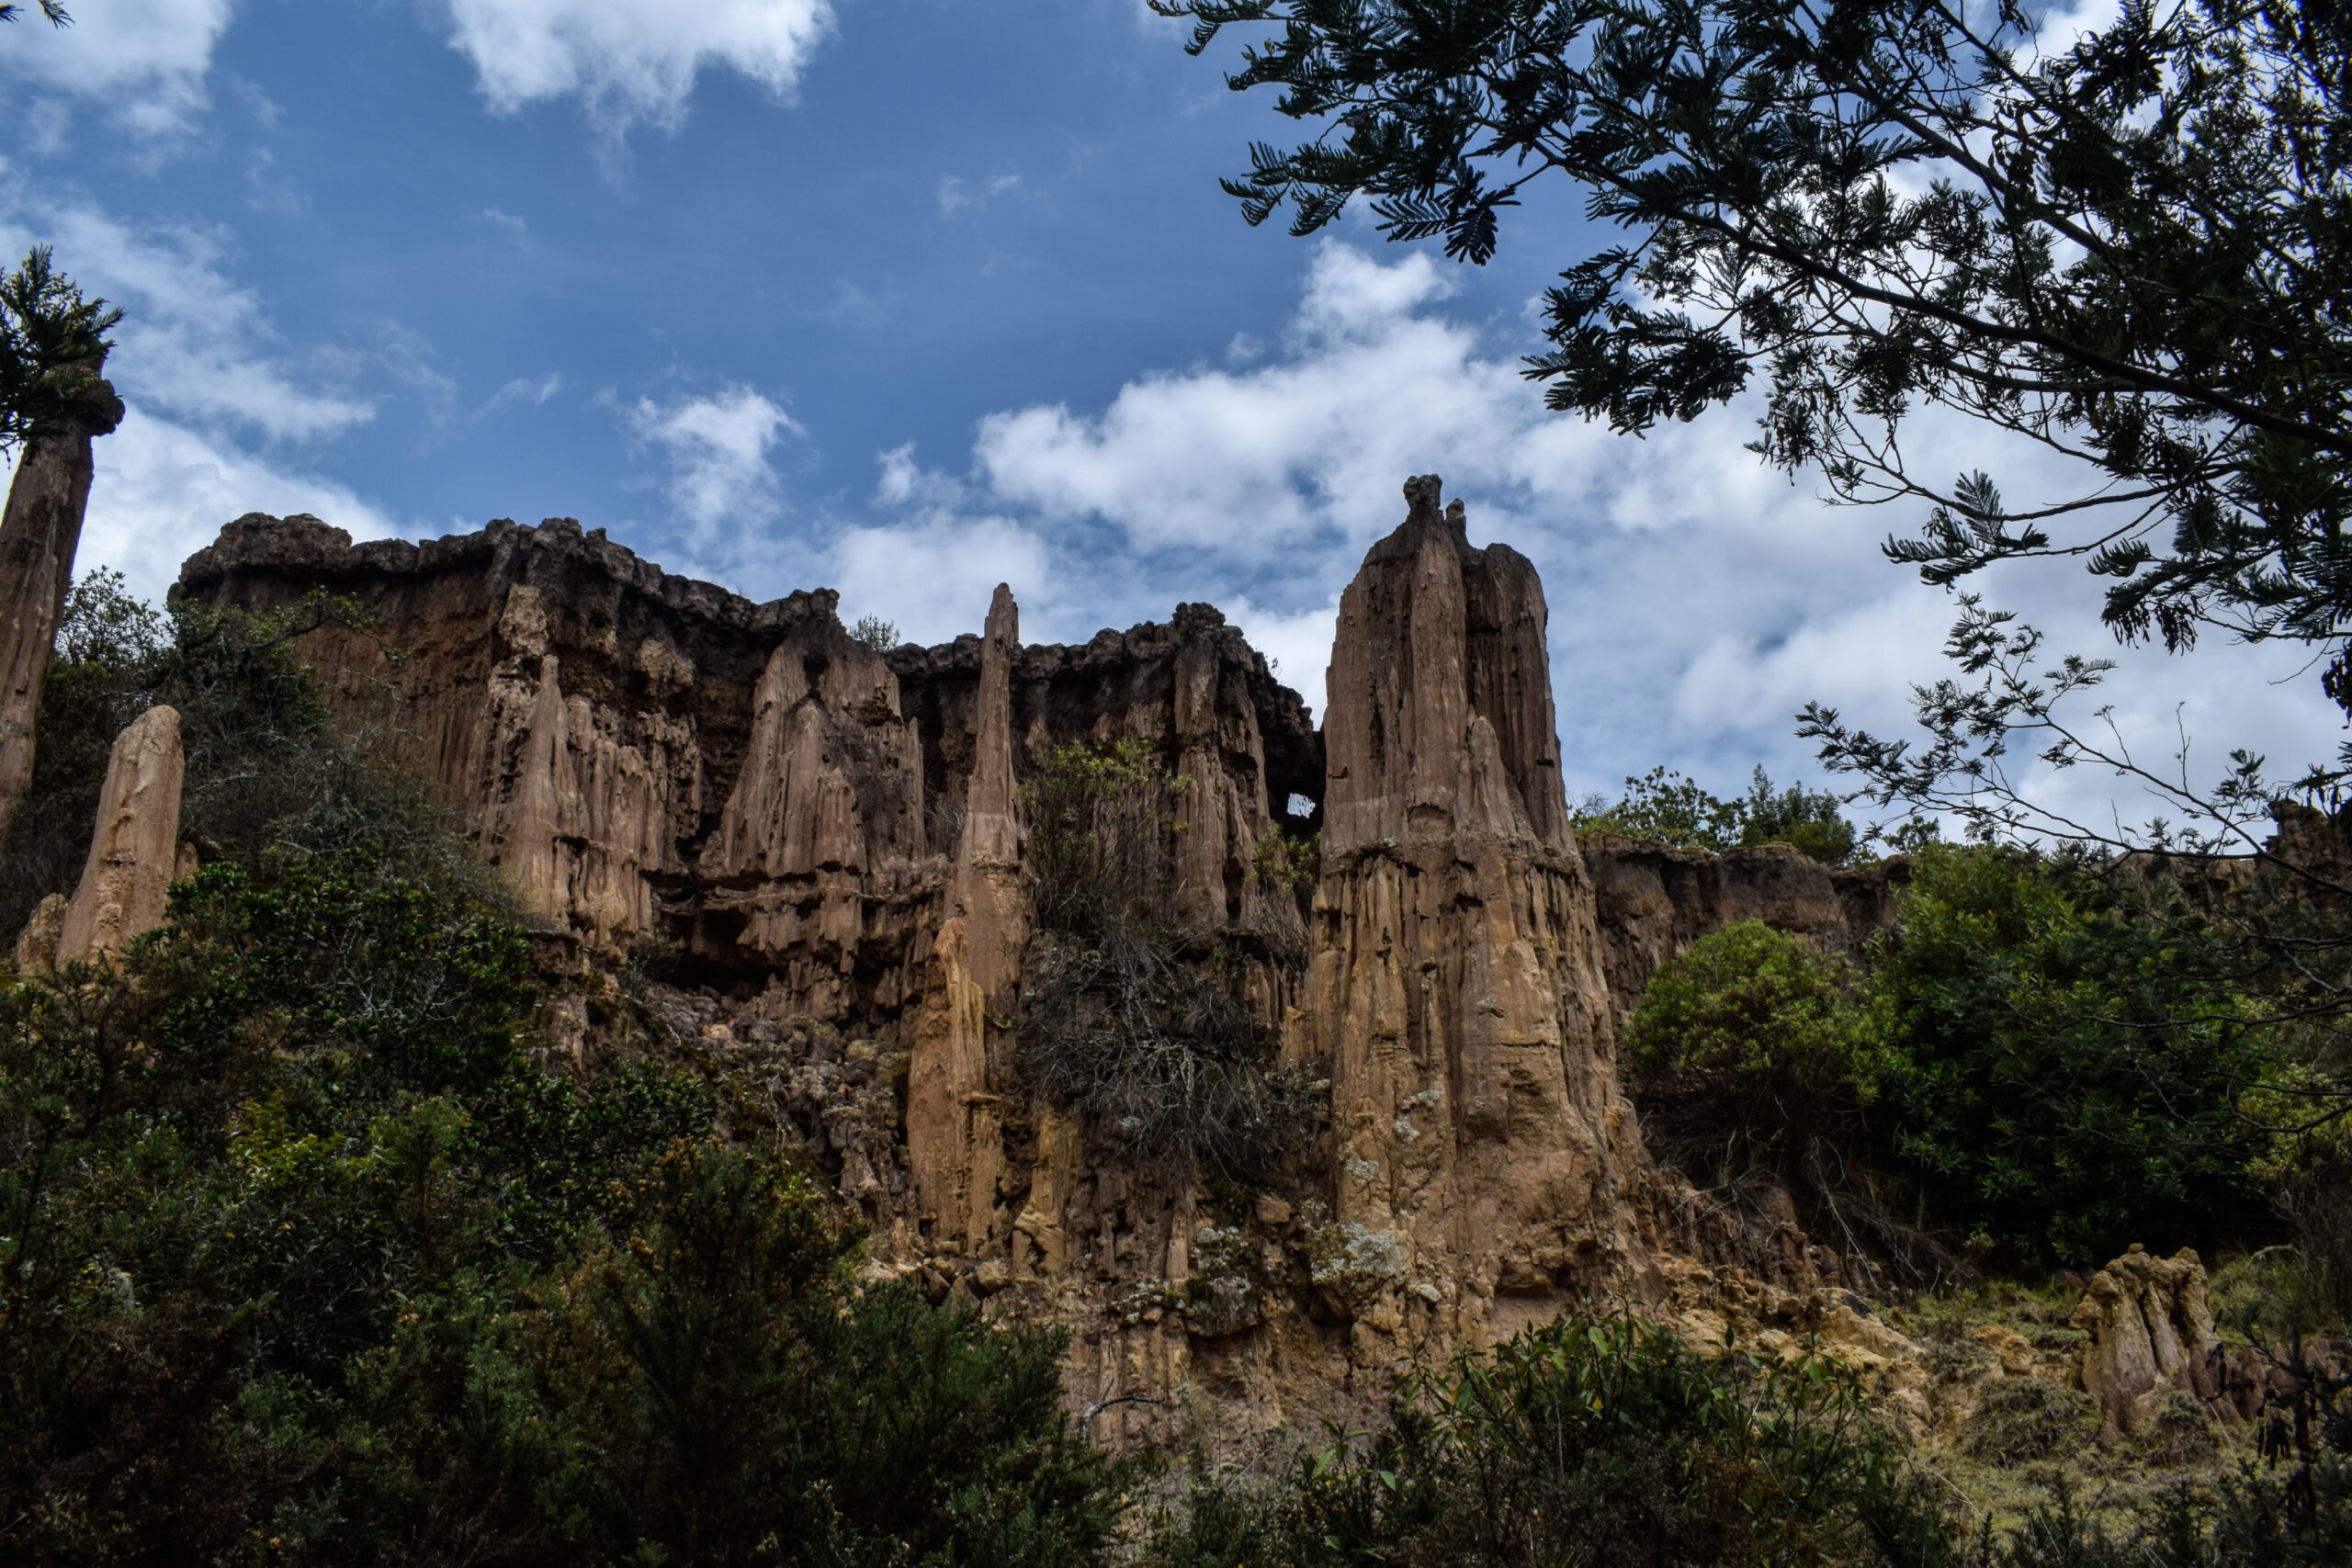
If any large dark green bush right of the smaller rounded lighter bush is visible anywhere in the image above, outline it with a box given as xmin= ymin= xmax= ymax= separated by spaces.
xmin=1870 ymin=846 xmax=2267 ymax=1265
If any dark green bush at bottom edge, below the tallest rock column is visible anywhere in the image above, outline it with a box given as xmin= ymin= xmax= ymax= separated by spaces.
xmin=1150 ymin=1316 xmax=1950 ymax=1568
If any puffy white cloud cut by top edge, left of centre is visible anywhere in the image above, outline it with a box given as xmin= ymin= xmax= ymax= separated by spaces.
xmin=447 ymin=0 xmax=832 ymax=134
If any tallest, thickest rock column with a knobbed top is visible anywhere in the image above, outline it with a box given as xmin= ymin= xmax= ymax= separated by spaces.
xmin=1291 ymin=475 xmax=1644 ymax=1333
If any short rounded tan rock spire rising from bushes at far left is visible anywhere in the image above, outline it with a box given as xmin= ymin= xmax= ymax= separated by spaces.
xmin=56 ymin=707 xmax=184 ymax=964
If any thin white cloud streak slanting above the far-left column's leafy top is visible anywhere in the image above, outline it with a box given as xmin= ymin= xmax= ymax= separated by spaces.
xmin=0 ymin=181 xmax=374 ymax=440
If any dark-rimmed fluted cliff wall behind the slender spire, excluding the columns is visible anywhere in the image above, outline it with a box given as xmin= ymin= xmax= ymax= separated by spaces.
xmin=174 ymin=514 xmax=1322 ymax=1021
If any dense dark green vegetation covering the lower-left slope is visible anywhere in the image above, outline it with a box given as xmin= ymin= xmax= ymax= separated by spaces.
xmin=0 ymin=592 xmax=1117 ymax=1563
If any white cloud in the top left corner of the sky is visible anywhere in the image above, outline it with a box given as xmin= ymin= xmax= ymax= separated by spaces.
xmin=0 ymin=0 xmax=235 ymax=139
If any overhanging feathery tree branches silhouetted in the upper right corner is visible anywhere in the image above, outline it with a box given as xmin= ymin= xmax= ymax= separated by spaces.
xmin=1152 ymin=0 xmax=2352 ymax=710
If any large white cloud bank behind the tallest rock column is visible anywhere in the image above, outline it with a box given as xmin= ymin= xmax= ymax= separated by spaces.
xmin=879 ymin=244 xmax=2335 ymax=820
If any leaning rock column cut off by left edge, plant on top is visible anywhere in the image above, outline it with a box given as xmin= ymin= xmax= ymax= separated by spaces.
xmin=0 ymin=365 xmax=122 ymax=851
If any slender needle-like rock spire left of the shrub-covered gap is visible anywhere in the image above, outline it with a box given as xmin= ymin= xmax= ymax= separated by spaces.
xmin=906 ymin=583 xmax=1030 ymax=1253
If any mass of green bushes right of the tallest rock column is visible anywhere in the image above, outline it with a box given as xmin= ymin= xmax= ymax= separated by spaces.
xmin=1625 ymin=846 xmax=2352 ymax=1304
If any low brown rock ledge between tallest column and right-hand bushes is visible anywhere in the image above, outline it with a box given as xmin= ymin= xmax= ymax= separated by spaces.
xmin=1578 ymin=835 xmax=1910 ymax=1025
